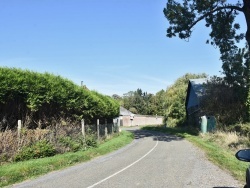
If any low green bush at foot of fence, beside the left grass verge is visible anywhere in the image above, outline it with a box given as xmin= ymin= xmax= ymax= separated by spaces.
xmin=15 ymin=140 xmax=56 ymax=161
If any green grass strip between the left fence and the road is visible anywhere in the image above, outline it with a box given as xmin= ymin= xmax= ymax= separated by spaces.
xmin=0 ymin=131 xmax=134 ymax=187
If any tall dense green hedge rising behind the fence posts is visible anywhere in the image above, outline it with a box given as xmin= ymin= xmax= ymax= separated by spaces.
xmin=0 ymin=67 xmax=119 ymax=129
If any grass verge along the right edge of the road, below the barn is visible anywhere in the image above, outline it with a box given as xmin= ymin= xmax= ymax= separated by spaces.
xmin=142 ymin=126 xmax=249 ymax=183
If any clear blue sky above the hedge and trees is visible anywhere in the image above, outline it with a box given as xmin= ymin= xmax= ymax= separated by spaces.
xmin=0 ymin=0 xmax=246 ymax=95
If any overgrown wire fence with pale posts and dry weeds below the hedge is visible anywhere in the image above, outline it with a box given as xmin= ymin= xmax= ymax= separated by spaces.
xmin=0 ymin=120 xmax=119 ymax=164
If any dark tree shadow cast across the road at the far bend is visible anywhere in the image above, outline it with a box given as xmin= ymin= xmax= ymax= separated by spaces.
xmin=128 ymin=129 xmax=183 ymax=142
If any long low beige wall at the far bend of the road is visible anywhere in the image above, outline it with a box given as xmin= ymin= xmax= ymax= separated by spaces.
xmin=120 ymin=115 xmax=163 ymax=126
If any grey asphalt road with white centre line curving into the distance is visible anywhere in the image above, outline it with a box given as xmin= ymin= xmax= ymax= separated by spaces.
xmin=12 ymin=129 xmax=241 ymax=188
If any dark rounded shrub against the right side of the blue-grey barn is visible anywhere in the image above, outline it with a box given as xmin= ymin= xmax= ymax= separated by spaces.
xmin=201 ymin=76 xmax=247 ymax=126
